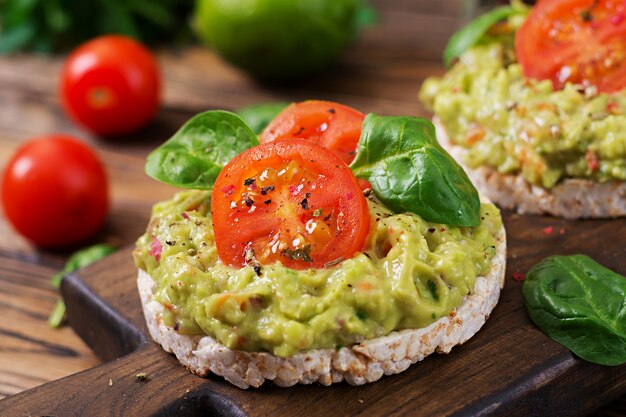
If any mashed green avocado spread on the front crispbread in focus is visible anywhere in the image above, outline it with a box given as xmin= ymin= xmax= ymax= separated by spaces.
xmin=133 ymin=191 xmax=502 ymax=357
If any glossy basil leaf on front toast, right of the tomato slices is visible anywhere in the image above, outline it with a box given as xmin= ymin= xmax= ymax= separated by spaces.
xmin=350 ymin=114 xmax=480 ymax=226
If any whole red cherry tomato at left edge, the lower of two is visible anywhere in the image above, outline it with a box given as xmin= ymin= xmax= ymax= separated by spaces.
xmin=2 ymin=135 xmax=108 ymax=247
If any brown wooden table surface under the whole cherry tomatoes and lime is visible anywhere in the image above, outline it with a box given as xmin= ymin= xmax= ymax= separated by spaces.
xmin=0 ymin=0 xmax=626 ymax=416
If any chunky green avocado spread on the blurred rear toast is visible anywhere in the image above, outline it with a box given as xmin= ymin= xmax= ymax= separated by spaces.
xmin=420 ymin=16 xmax=626 ymax=188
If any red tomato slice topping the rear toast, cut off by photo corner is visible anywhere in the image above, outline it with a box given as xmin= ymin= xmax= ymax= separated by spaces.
xmin=515 ymin=0 xmax=626 ymax=92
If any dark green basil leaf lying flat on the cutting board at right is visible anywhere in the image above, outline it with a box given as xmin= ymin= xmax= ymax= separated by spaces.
xmin=524 ymin=255 xmax=626 ymax=365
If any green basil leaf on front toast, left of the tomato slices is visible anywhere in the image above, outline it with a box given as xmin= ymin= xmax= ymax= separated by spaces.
xmin=146 ymin=110 xmax=259 ymax=190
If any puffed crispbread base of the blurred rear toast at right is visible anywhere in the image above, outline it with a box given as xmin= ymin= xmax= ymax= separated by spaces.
xmin=433 ymin=117 xmax=626 ymax=219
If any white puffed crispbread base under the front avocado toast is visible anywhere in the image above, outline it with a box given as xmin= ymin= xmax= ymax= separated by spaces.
xmin=137 ymin=226 xmax=506 ymax=389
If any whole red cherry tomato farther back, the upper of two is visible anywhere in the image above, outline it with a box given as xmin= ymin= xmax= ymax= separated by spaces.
xmin=61 ymin=35 xmax=161 ymax=136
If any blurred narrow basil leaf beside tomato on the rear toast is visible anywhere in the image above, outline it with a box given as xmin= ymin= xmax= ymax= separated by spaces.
xmin=443 ymin=6 xmax=520 ymax=67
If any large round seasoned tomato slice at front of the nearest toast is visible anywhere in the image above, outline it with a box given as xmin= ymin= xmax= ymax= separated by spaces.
xmin=211 ymin=139 xmax=370 ymax=269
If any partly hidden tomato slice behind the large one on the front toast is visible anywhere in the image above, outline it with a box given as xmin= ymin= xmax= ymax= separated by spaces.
xmin=261 ymin=100 xmax=365 ymax=164
